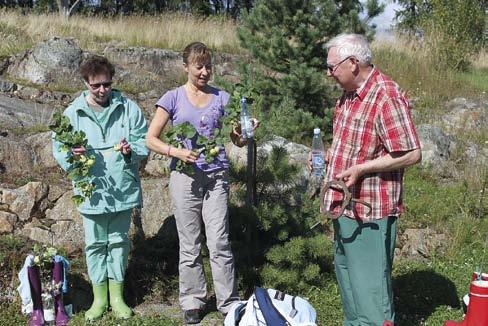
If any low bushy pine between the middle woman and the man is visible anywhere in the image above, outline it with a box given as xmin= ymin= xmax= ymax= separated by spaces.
xmin=230 ymin=147 xmax=332 ymax=293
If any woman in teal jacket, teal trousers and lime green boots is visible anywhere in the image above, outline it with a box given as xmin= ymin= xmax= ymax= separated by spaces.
xmin=53 ymin=56 xmax=148 ymax=320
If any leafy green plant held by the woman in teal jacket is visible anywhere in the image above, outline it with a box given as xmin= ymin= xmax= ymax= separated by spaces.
xmin=49 ymin=112 xmax=95 ymax=205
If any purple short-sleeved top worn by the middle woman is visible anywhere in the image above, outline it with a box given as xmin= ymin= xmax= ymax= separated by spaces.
xmin=156 ymin=86 xmax=230 ymax=172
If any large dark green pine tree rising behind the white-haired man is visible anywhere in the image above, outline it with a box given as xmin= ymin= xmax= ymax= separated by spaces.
xmin=237 ymin=0 xmax=382 ymax=141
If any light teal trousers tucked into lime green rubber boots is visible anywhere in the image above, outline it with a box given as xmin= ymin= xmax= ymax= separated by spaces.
xmin=81 ymin=209 xmax=132 ymax=284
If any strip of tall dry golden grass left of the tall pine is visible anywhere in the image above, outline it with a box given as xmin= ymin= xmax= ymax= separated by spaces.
xmin=0 ymin=10 xmax=240 ymax=56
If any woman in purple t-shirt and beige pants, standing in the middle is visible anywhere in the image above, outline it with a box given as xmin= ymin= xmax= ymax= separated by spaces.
xmin=146 ymin=42 xmax=257 ymax=324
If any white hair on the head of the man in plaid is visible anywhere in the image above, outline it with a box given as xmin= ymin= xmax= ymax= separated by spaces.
xmin=325 ymin=34 xmax=373 ymax=65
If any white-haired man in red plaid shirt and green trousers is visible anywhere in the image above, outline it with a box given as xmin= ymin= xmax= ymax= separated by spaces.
xmin=323 ymin=34 xmax=421 ymax=326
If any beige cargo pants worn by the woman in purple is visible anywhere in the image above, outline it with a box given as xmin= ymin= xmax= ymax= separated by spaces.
xmin=169 ymin=169 xmax=239 ymax=313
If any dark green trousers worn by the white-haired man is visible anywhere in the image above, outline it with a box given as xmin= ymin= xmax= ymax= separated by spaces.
xmin=333 ymin=216 xmax=397 ymax=326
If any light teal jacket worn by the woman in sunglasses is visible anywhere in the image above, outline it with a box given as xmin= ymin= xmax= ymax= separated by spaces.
xmin=52 ymin=90 xmax=149 ymax=214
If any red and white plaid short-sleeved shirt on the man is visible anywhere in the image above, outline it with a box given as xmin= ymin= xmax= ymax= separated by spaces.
xmin=324 ymin=68 xmax=420 ymax=219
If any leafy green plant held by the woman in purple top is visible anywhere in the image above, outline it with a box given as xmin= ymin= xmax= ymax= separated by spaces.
xmin=166 ymin=84 xmax=257 ymax=174
